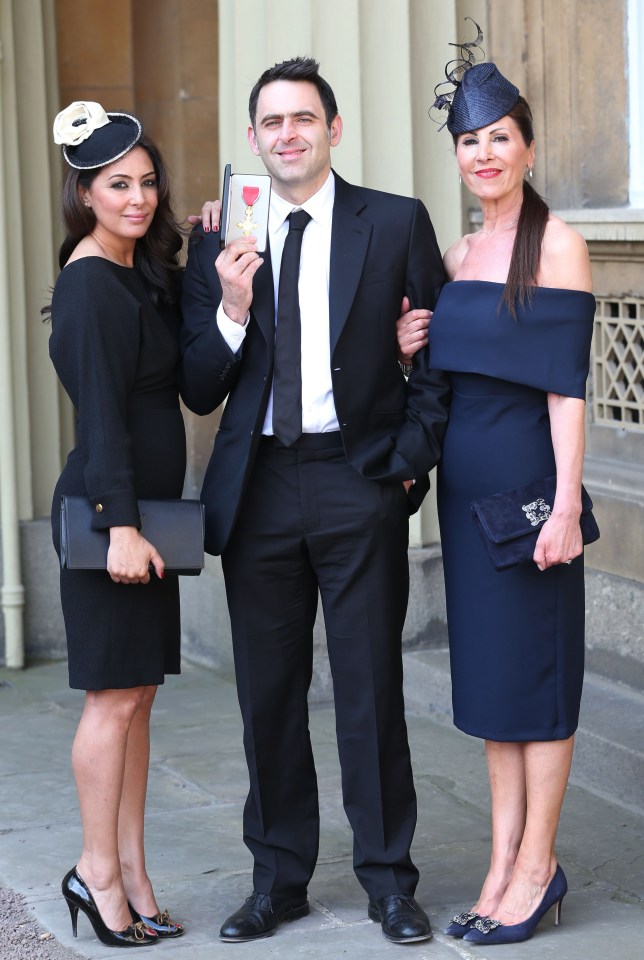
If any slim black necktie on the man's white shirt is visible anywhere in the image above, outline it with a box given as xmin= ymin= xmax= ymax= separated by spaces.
xmin=273 ymin=210 xmax=311 ymax=447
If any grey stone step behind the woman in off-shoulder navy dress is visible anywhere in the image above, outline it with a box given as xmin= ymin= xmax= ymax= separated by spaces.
xmin=404 ymin=649 xmax=644 ymax=815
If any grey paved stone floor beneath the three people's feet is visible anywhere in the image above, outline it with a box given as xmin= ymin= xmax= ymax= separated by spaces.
xmin=0 ymin=662 xmax=644 ymax=960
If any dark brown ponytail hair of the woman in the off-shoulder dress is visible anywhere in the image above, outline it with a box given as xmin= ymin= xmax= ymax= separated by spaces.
xmin=454 ymin=97 xmax=550 ymax=319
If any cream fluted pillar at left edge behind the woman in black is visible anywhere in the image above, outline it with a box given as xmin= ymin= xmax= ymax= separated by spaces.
xmin=0 ymin=0 xmax=61 ymax=666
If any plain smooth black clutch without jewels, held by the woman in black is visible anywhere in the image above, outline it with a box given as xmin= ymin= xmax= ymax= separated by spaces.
xmin=60 ymin=495 xmax=204 ymax=576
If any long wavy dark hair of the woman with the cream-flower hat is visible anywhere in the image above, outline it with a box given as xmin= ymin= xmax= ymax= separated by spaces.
xmin=40 ymin=136 xmax=184 ymax=319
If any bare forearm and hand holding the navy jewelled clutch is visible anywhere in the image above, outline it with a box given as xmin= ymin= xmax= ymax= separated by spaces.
xmin=533 ymin=393 xmax=585 ymax=570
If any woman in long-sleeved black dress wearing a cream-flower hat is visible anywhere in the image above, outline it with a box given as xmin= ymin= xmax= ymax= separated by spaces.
xmin=47 ymin=102 xmax=186 ymax=946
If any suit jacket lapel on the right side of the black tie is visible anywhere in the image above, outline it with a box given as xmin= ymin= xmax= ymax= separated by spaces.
xmin=329 ymin=174 xmax=371 ymax=356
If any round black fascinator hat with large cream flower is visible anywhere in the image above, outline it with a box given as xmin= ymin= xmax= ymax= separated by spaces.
xmin=54 ymin=100 xmax=143 ymax=170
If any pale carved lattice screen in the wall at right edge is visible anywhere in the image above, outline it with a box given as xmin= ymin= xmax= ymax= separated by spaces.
xmin=593 ymin=298 xmax=644 ymax=432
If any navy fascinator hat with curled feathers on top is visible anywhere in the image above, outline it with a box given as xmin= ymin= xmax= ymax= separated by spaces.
xmin=430 ymin=17 xmax=519 ymax=136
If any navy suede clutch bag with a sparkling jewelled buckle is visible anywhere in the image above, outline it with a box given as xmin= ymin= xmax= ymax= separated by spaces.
xmin=470 ymin=477 xmax=599 ymax=570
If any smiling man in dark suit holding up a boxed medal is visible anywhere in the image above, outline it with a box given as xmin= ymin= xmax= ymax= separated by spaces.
xmin=181 ymin=58 xmax=449 ymax=943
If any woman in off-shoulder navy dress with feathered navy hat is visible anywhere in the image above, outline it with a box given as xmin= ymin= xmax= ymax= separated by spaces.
xmin=399 ymin=28 xmax=595 ymax=944
